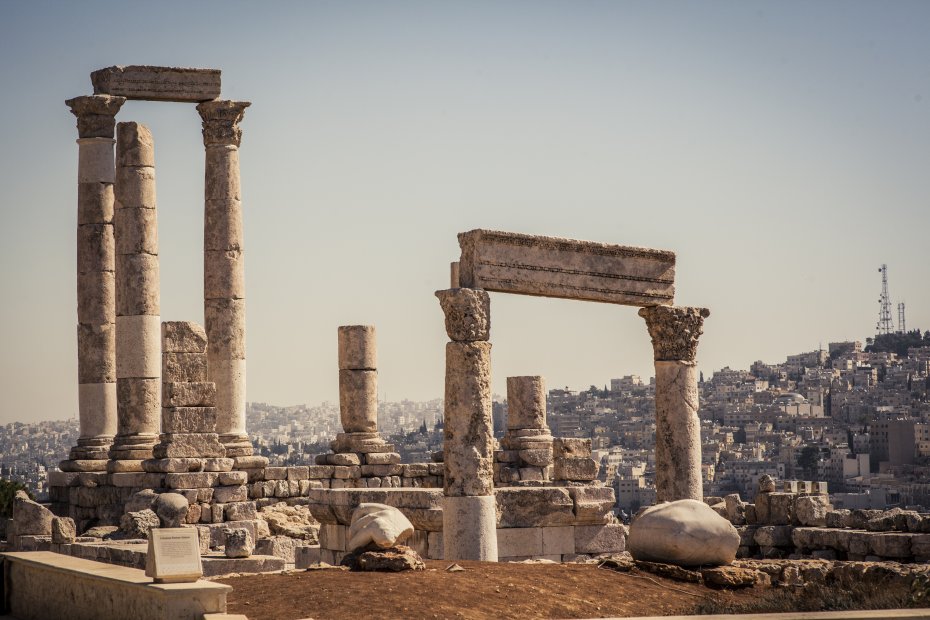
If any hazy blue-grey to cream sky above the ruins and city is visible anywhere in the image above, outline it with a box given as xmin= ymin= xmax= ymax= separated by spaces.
xmin=0 ymin=0 xmax=930 ymax=423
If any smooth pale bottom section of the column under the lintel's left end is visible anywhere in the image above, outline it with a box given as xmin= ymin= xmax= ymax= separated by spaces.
xmin=442 ymin=495 xmax=497 ymax=562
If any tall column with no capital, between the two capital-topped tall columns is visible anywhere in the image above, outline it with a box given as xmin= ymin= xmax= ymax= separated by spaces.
xmin=107 ymin=123 xmax=161 ymax=473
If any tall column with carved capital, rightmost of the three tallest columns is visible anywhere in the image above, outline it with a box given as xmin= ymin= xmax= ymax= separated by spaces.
xmin=197 ymin=100 xmax=252 ymax=457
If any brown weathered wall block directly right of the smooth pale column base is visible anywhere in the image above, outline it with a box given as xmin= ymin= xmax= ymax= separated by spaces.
xmin=494 ymin=487 xmax=575 ymax=528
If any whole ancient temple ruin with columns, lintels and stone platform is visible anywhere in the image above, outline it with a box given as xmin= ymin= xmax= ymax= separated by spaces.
xmin=34 ymin=66 xmax=709 ymax=571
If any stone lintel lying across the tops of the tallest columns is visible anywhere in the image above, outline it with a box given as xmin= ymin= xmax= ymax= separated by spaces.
xmin=90 ymin=65 xmax=220 ymax=103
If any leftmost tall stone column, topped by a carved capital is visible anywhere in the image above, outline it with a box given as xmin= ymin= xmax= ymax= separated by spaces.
xmin=60 ymin=95 xmax=126 ymax=471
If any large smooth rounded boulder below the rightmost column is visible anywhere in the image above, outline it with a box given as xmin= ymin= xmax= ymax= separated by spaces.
xmin=627 ymin=499 xmax=740 ymax=566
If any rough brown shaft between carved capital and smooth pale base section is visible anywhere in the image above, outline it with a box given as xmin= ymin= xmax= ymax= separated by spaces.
xmin=443 ymin=342 xmax=494 ymax=496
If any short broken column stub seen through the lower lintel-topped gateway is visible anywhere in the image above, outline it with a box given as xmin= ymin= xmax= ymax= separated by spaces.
xmin=498 ymin=376 xmax=552 ymax=483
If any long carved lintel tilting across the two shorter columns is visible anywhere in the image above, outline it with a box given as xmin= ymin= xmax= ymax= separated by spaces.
xmin=459 ymin=230 xmax=675 ymax=306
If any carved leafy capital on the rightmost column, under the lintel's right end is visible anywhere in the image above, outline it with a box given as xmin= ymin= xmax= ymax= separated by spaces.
xmin=639 ymin=306 xmax=710 ymax=362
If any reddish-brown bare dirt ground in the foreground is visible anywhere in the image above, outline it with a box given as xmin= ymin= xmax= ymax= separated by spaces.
xmin=216 ymin=561 xmax=761 ymax=620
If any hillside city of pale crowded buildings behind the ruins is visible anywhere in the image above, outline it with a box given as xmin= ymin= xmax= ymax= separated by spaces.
xmin=0 ymin=331 xmax=930 ymax=517
